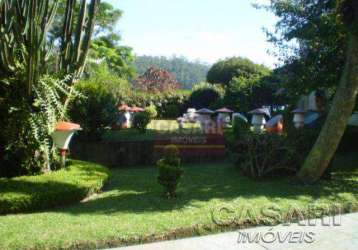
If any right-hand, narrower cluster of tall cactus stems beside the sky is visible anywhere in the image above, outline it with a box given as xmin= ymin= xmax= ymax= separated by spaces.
xmin=60 ymin=0 xmax=100 ymax=80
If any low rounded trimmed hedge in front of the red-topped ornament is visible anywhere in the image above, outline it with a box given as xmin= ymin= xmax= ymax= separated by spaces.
xmin=0 ymin=161 xmax=109 ymax=214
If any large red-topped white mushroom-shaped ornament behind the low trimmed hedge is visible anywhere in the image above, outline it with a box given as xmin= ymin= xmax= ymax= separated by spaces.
xmin=51 ymin=121 xmax=81 ymax=166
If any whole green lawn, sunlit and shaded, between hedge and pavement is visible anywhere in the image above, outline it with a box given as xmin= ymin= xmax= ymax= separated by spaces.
xmin=0 ymin=154 xmax=358 ymax=249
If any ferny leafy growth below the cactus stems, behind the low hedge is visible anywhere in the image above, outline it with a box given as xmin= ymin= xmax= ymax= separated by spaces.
xmin=0 ymin=76 xmax=79 ymax=177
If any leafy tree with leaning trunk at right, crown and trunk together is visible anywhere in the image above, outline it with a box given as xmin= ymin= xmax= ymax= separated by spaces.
xmin=268 ymin=0 xmax=358 ymax=182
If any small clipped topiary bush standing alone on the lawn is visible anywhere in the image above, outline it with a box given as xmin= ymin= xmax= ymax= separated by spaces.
xmin=157 ymin=145 xmax=184 ymax=198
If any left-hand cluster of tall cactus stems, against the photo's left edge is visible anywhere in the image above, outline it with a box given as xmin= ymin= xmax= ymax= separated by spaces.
xmin=0 ymin=0 xmax=58 ymax=95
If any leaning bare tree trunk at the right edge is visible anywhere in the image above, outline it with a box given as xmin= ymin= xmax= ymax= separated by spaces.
xmin=298 ymin=32 xmax=358 ymax=183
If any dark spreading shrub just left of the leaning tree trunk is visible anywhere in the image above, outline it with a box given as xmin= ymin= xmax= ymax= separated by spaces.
xmin=225 ymin=114 xmax=324 ymax=179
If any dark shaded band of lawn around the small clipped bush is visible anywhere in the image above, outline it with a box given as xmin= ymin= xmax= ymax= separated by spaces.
xmin=62 ymin=156 xmax=358 ymax=215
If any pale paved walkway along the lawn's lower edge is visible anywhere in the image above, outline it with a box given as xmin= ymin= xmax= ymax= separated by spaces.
xmin=112 ymin=213 xmax=358 ymax=250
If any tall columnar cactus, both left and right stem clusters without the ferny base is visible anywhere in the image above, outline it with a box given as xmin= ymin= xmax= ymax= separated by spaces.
xmin=0 ymin=0 xmax=100 ymax=93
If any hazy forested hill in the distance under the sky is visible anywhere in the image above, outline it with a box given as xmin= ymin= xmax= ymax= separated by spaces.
xmin=134 ymin=56 xmax=210 ymax=89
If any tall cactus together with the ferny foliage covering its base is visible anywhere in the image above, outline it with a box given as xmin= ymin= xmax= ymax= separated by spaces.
xmin=0 ymin=0 xmax=99 ymax=176
